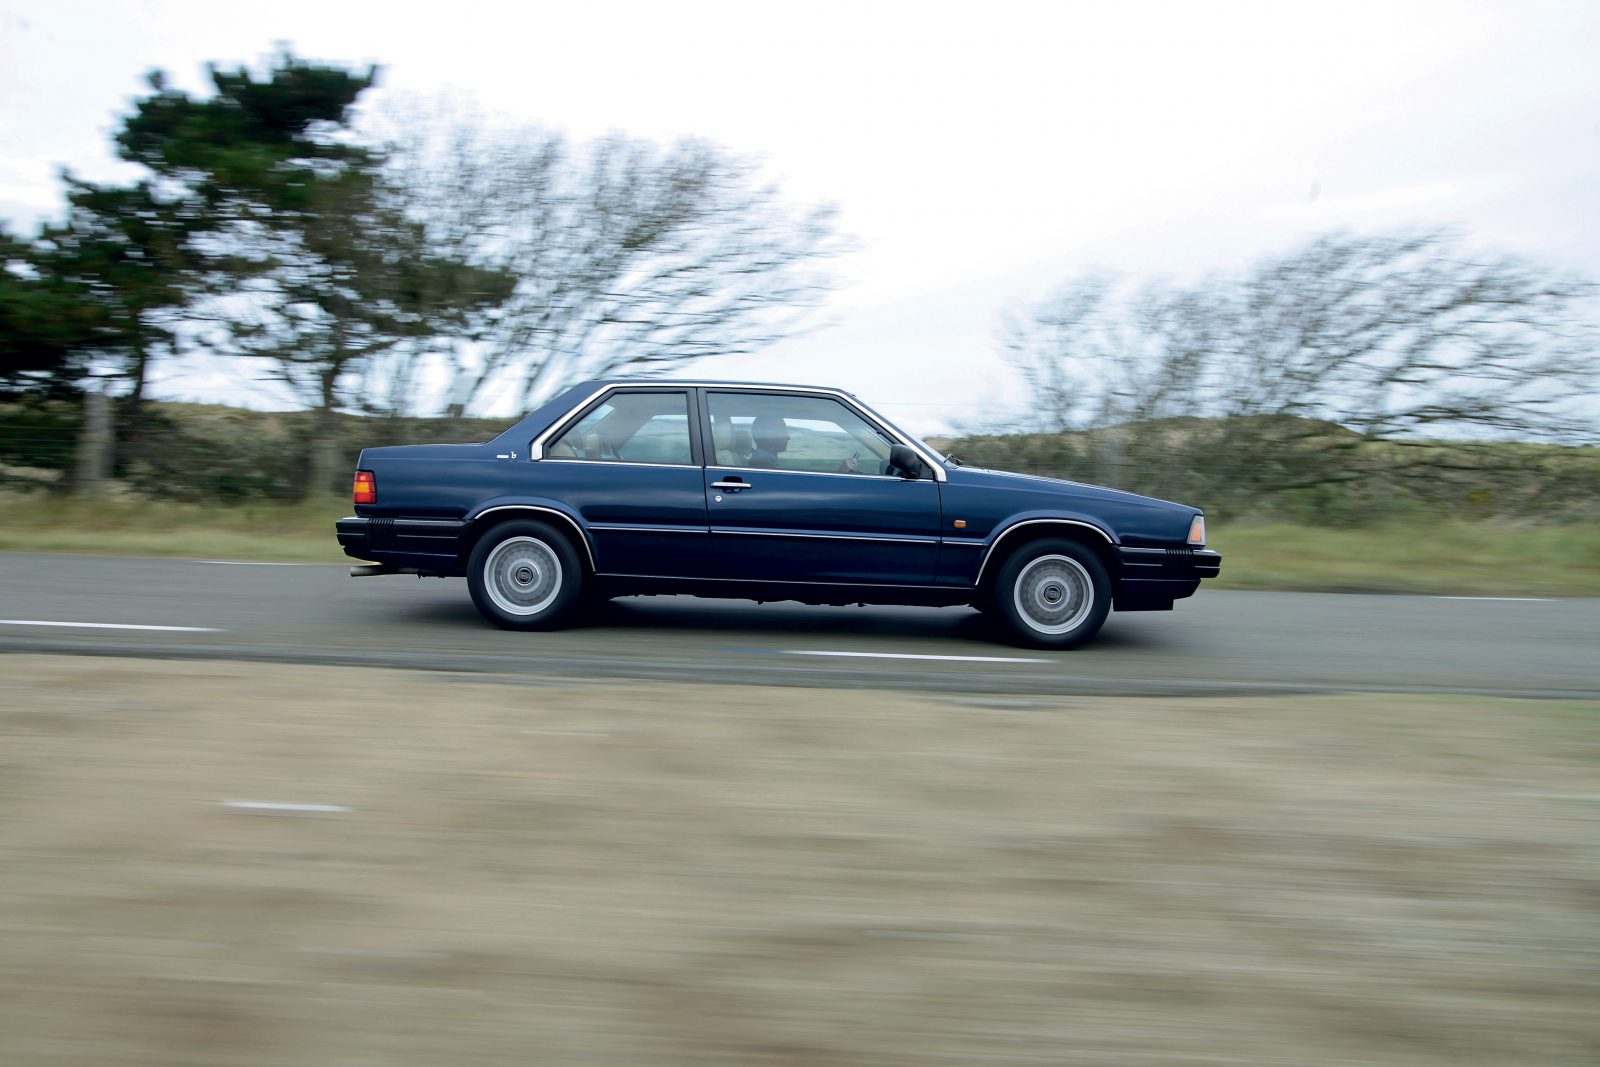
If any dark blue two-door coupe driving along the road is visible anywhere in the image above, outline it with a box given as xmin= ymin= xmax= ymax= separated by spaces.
xmin=338 ymin=379 xmax=1221 ymax=648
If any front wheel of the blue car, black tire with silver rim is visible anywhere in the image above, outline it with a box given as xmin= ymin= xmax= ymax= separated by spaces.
xmin=989 ymin=541 xmax=1110 ymax=649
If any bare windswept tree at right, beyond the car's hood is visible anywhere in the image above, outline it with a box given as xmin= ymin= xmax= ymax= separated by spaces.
xmin=1000 ymin=230 xmax=1600 ymax=511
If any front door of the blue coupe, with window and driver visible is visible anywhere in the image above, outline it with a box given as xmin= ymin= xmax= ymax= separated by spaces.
xmin=704 ymin=389 xmax=939 ymax=585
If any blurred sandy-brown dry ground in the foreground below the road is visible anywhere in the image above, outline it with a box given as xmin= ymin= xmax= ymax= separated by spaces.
xmin=0 ymin=656 xmax=1600 ymax=1067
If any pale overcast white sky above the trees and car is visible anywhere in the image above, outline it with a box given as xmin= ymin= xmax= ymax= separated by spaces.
xmin=0 ymin=0 xmax=1600 ymax=434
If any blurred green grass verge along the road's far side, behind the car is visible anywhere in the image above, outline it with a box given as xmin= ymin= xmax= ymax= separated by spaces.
xmin=0 ymin=496 xmax=1600 ymax=597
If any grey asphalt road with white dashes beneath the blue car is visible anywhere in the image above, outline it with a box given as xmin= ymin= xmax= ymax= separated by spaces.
xmin=0 ymin=553 xmax=1600 ymax=699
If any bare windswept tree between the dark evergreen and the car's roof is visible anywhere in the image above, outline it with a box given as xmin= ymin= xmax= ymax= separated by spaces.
xmin=372 ymin=112 xmax=842 ymax=414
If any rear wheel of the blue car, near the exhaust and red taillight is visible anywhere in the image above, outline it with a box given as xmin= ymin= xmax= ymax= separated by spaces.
xmin=467 ymin=520 xmax=584 ymax=630
